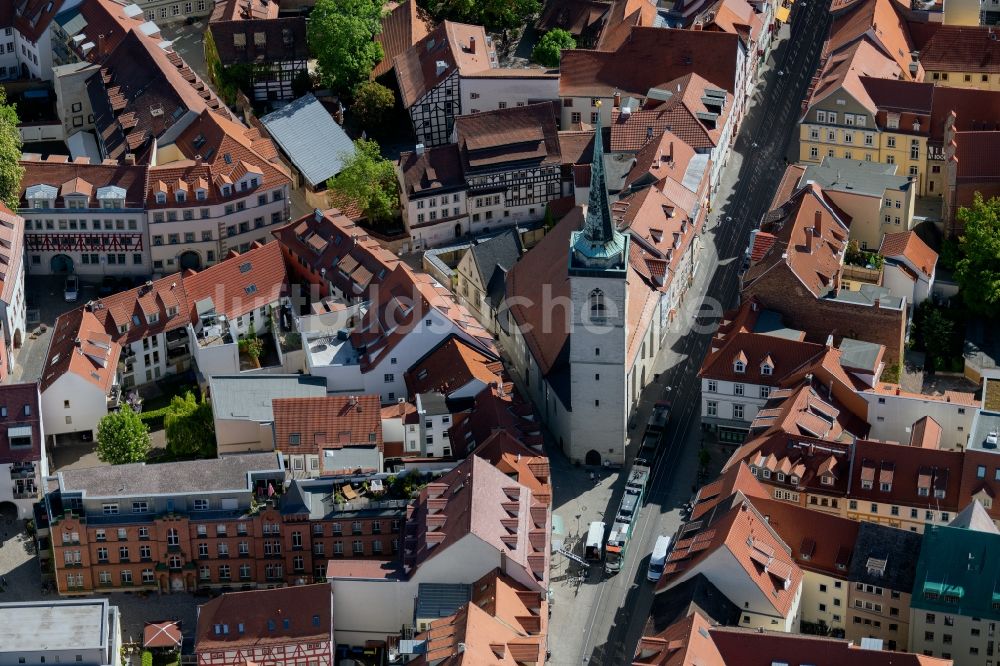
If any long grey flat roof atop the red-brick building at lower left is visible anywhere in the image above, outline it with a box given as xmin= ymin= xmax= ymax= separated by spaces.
xmin=59 ymin=452 xmax=283 ymax=498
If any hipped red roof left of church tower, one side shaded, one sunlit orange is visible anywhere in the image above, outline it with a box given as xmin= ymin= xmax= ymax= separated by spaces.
xmin=404 ymin=336 xmax=503 ymax=396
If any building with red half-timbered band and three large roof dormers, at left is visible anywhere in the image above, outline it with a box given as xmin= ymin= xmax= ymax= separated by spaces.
xmin=19 ymin=155 xmax=150 ymax=277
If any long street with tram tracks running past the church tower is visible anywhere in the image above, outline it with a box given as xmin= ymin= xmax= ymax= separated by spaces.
xmin=549 ymin=0 xmax=831 ymax=666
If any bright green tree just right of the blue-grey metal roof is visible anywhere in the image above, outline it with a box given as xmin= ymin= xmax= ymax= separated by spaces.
xmin=326 ymin=139 xmax=399 ymax=225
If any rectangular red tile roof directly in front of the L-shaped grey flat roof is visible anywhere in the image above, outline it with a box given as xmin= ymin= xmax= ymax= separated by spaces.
xmin=271 ymin=395 xmax=382 ymax=462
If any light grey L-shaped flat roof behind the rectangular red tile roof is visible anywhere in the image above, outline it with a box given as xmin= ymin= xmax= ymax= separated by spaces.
xmin=208 ymin=375 xmax=326 ymax=423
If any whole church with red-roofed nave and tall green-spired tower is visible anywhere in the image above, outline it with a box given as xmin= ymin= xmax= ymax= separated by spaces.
xmin=498 ymin=115 xmax=707 ymax=465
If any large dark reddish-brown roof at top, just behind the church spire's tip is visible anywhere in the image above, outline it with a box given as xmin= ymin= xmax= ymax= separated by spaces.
xmin=559 ymin=28 xmax=739 ymax=97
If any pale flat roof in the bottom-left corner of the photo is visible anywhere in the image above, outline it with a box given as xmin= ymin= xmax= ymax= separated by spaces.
xmin=0 ymin=599 xmax=109 ymax=654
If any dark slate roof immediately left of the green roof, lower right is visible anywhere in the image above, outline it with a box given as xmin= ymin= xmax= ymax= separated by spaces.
xmin=848 ymin=523 xmax=923 ymax=592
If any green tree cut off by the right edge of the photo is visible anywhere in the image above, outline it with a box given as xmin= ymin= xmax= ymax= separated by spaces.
xmin=955 ymin=193 xmax=1000 ymax=317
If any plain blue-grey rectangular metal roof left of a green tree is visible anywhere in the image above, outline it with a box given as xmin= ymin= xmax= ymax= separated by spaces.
xmin=260 ymin=93 xmax=354 ymax=187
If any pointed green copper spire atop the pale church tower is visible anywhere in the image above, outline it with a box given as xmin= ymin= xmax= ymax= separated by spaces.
xmin=569 ymin=107 xmax=628 ymax=273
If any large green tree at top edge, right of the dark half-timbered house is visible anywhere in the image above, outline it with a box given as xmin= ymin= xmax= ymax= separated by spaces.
xmin=306 ymin=0 xmax=383 ymax=92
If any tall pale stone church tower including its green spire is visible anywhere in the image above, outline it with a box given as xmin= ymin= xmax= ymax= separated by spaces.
xmin=564 ymin=111 xmax=629 ymax=464
